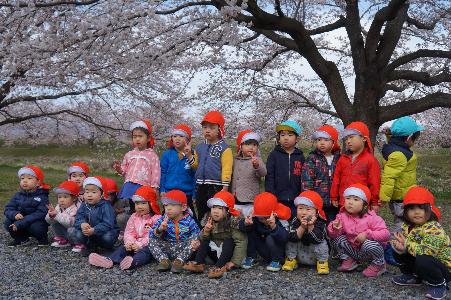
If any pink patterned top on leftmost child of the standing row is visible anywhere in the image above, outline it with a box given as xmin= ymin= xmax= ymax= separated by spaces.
xmin=120 ymin=148 xmax=160 ymax=188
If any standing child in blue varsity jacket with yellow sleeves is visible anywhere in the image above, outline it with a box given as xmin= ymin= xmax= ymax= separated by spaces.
xmin=185 ymin=111 xmax=233 ymax=220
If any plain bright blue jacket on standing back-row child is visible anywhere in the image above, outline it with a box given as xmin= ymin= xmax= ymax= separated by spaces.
xmin=160 ymin=147 xmax=196 ymax=196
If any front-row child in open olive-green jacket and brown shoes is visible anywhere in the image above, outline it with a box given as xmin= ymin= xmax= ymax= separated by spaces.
xmin=183 ymin=191 xmax=247 ymax=278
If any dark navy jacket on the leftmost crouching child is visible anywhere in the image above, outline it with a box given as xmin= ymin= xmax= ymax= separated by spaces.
xmin=5 ymin=189 xmax=49 ymax=229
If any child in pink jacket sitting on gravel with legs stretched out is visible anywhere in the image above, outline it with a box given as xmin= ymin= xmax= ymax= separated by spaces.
xmin=88 ymin=186 xmax=161 ymax=270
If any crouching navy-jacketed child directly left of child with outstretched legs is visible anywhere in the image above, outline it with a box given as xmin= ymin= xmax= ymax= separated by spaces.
xmin=69 ymin=177 xmax=119 ymax=256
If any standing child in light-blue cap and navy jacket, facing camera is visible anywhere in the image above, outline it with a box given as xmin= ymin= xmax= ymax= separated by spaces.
xmin=265 ymin=120 xmax=304 ymax=216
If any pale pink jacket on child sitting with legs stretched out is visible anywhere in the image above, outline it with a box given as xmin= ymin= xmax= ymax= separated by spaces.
xmin=124 ymin=213 xmax=161 ymax=248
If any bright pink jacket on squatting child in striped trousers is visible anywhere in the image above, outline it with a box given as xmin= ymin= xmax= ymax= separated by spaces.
xmin=327 ymin=207 xmax=390 ymax=248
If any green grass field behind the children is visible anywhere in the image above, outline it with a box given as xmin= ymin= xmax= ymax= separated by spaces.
xmin=0 ymin=140 xmax=451 ymax=233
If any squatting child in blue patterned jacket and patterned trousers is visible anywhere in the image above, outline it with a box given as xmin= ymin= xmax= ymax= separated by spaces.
xmin=149 ymin=190 xmax=200 ymax=273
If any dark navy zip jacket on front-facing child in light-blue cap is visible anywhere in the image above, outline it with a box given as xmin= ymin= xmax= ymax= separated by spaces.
xmin=265 ymin=145 xmax=305 ymax=207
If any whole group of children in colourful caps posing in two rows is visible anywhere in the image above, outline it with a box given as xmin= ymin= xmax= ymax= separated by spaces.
xmin=5 ymin=111 xmax=451 ymax=299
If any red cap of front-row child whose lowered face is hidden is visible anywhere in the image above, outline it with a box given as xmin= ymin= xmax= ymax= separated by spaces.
xmin=254 ymin=192 xmax=291 ymax=220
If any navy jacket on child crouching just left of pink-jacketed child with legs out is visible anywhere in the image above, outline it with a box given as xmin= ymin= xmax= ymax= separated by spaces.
xmin=74 ymin=199 xmax=119 ymax=236
